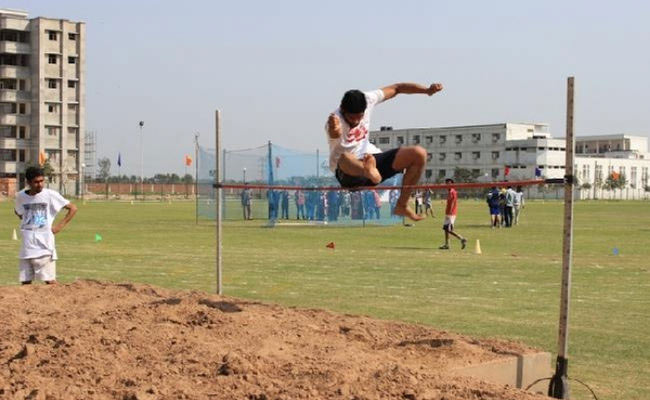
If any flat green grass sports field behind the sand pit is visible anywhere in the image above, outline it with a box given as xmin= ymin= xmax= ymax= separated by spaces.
xmin=0 ymin=201 xmax=650 ymax=400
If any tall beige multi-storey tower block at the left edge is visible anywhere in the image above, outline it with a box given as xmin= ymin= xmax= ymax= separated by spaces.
xmin=0 ymin=9 xmax=86 ymax=194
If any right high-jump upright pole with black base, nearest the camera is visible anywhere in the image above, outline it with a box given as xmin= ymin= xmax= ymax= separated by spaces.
xmin=548 ymin=76 xmax=575 ymax=399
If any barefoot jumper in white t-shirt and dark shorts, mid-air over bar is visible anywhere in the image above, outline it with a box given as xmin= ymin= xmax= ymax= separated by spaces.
xmin=325 ymin=83 xmax=442 ymax=221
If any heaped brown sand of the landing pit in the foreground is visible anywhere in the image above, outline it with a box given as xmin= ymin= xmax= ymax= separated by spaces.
xmin=0 ymin=281 xmax=547 ymax=400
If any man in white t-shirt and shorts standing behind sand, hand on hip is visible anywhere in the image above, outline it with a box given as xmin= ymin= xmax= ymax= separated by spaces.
xmin=14 ymin=167 xmax=77 ymax=285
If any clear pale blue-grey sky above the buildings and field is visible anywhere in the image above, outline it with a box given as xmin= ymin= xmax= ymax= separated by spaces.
xmin=0 ymin=0 xmax=650 ymax=175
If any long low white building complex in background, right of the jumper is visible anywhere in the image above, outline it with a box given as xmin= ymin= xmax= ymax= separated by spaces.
xmin=370 ymin=123 xmax=650 ymax=198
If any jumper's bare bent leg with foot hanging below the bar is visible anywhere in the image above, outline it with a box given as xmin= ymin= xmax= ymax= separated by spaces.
xmin=393 ymin=146 xmax=427 ymax=221
